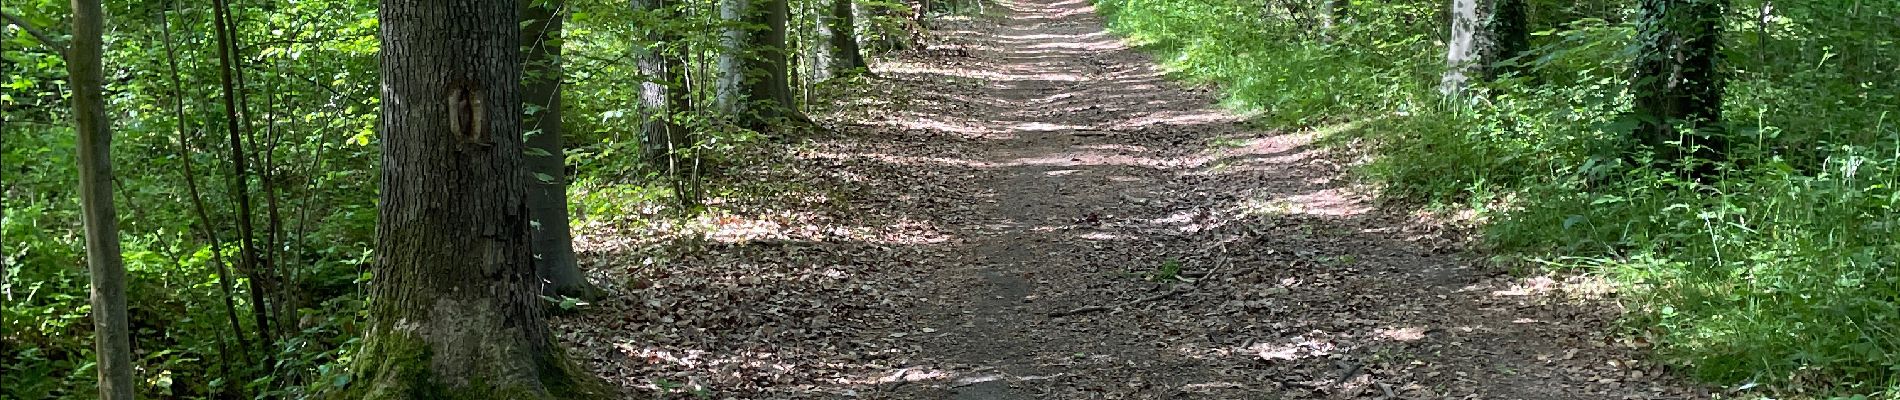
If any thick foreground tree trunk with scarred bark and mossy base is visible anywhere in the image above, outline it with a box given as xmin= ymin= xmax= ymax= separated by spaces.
xmin=340 ymin=0 xmax=600 ymax=398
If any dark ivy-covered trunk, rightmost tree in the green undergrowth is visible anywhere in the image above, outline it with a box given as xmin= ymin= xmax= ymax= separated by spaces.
xmin=1630 ymin=0 xmax=1727 ymax=165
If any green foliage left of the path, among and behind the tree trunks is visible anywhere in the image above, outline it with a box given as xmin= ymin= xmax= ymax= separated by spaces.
xmin=0 ymin=0 xmax=908 ymax=400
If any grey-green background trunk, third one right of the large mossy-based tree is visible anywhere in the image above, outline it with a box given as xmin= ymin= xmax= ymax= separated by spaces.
xmin=716 ymin=0 xmax=798 ymax=131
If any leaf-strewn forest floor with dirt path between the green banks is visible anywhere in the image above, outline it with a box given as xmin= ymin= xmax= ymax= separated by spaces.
xmin=557 ymin=0 xmax=1708 ymax=400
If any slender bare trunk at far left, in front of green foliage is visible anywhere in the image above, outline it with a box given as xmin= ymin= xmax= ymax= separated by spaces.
xmin=67 ymin=0 xmax=133 ymax=400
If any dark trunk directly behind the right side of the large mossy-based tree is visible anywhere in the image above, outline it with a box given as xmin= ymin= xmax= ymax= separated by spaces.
xmin=521 ymin=0 xmax=599 ymax=300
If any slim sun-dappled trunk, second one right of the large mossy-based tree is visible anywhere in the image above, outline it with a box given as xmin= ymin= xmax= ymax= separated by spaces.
xmin=633 ymin=0 xmax=692 ymax=166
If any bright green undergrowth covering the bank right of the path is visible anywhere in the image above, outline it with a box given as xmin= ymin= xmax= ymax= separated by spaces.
xmin=1096 ymin=0 xmax=1900 ymax=398
